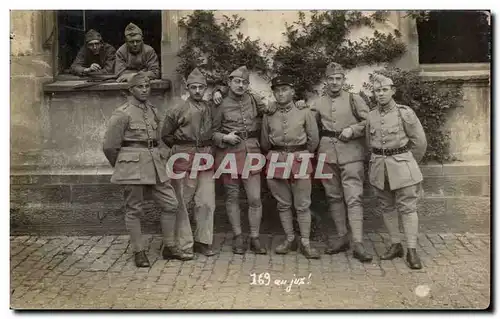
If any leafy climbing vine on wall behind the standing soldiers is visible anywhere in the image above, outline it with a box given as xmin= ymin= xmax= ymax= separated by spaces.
xmin=177 ymin=10 xmax=462 ymax=162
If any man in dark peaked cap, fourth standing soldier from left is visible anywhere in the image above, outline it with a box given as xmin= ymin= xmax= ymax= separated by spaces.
xmin=261 ymin=76 xmax=320 ymax=259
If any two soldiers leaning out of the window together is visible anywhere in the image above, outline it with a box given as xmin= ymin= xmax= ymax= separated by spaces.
xmin=70 ymin=23 xmax=160 ymax=82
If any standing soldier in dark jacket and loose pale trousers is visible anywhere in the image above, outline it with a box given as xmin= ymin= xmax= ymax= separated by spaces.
xmin=162 ymin=68 xmax=215 ymax=259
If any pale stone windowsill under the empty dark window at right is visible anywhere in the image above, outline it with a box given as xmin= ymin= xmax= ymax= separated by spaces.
xmin=420 ymin=63 xmax=491 ymax=83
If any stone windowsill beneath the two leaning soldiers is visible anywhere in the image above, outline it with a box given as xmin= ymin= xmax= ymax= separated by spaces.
xmin=43 ymin=79 xmax=171 ymax=93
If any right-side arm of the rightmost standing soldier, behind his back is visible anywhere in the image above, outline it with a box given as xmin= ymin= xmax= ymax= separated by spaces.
xmin=398 ymin=105 xmax=427 ymax=162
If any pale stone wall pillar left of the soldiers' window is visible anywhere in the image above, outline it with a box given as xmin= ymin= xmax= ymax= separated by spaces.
xmin=10 ymin=10 xmax=53 ymax=169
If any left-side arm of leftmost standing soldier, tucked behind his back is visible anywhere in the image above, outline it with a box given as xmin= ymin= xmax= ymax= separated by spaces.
xmin=103 ymin=108 xmax=129 ymax=167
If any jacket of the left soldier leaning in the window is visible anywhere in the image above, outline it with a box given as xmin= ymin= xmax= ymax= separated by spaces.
xmin=71 ymin=43 xmax=116 ymax=75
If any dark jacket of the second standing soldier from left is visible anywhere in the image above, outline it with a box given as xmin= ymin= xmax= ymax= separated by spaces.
xmin=161 ymin=97 xmax=213 ymax=173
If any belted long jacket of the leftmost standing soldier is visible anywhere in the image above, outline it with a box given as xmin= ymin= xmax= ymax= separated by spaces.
xmin=103 ymin=98 xmax=170 ymax=185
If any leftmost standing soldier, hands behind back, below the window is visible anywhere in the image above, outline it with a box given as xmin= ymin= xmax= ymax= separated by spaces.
xmin=103 ymin=72 xmax=178 ymax=267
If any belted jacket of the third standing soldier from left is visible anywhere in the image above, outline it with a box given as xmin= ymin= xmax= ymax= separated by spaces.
xmin=213 ymin=92 xmax=266 ymax=174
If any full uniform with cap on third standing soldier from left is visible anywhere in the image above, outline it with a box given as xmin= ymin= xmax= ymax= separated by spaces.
xmin=213 ymin=67 xmax=266 ymax=254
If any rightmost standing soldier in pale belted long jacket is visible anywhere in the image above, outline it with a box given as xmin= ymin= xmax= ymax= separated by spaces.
xmin=366 ymin=75 xmax=427 ymax=269
